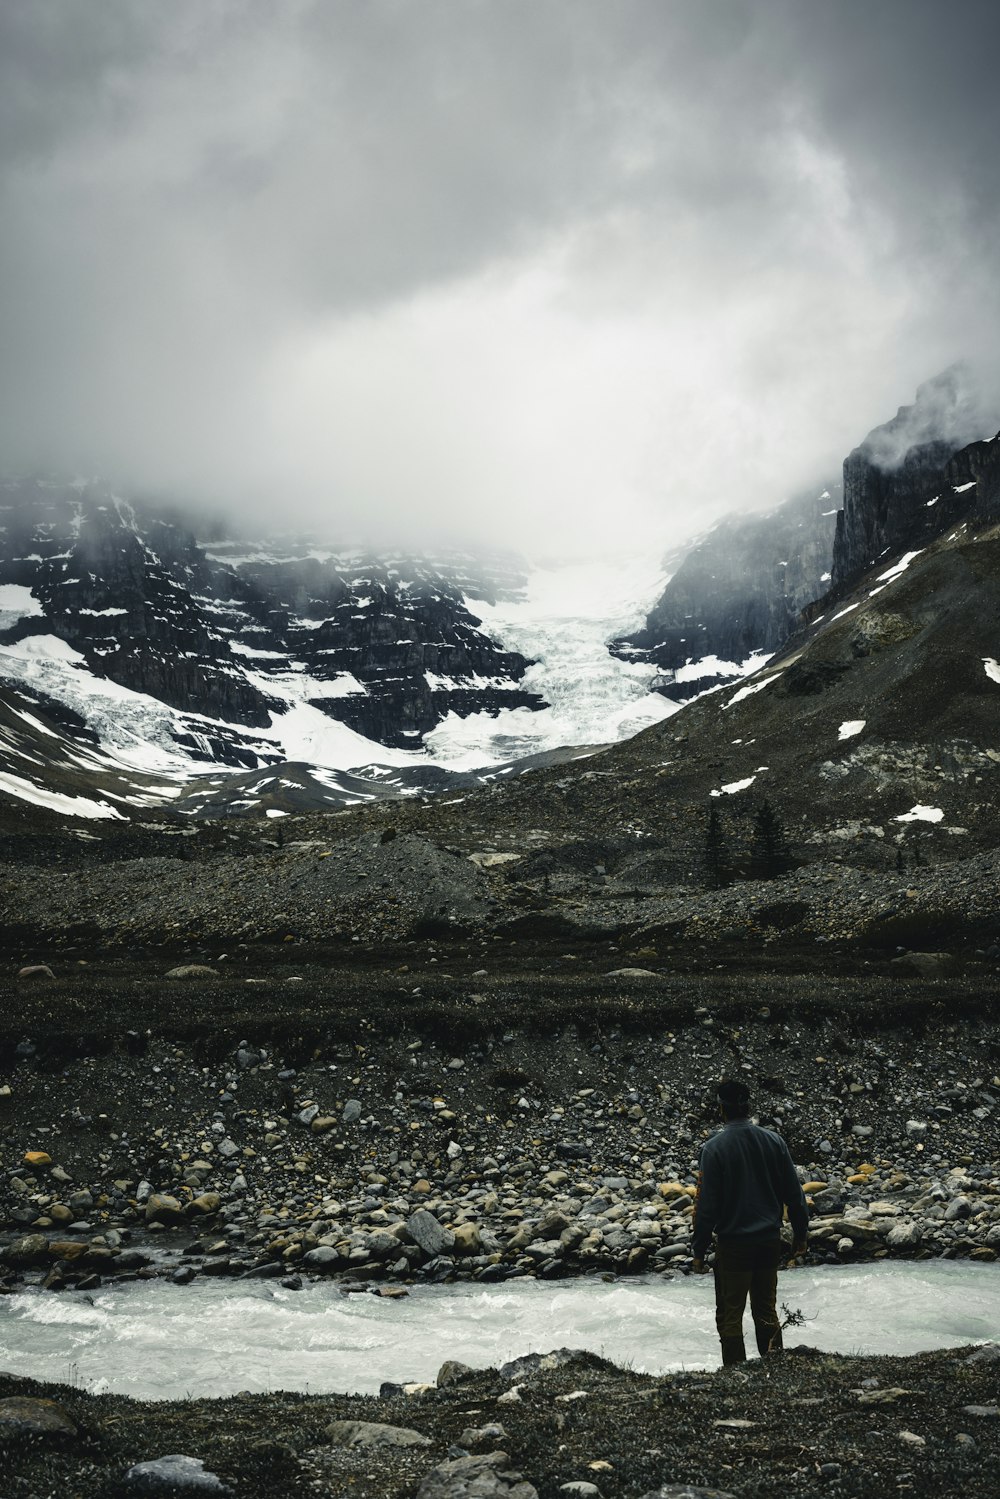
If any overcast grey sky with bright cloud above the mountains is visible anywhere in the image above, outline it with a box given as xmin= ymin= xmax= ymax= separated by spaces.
xmin=0 ymin=0 xmax=1000 ymax=555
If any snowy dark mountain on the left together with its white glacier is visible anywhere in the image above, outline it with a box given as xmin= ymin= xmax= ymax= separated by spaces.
xmin=0 ymin=480 xmax=672 ymax=812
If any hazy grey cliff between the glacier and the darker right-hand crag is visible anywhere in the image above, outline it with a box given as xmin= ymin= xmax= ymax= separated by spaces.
xmin=613 ymin=481 xmax=840 ymax=700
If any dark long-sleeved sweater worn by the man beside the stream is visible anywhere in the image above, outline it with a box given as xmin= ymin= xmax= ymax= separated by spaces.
xmin=691 ymin=1120 xmax=810 ymax=1259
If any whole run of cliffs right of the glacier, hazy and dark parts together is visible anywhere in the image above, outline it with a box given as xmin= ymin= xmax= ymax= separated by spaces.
xmin=613 ymin=364 xmax=1000 ymax=700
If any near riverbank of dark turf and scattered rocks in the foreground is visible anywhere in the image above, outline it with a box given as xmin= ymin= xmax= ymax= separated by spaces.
xmin=0 ymin=1345 xmax=1000 ymax=1499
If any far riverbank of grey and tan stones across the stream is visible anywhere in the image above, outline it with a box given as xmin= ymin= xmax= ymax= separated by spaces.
xmin=0 ymin=943 xmax=1000 ymax=1289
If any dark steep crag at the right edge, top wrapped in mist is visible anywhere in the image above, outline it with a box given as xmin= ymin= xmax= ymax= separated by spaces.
xmin=831 ymin=367 xmax=1000 ymax=588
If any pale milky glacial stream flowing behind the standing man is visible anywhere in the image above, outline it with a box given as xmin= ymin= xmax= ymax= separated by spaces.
xmin=0 ymin=1261 xmax=1000 ymax=1399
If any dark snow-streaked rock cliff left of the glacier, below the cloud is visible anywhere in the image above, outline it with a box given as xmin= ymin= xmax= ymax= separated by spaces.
xmin=0 ymin=480 xmax=544 ymax=766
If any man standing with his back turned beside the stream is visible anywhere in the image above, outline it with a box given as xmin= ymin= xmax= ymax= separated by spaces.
xmin=691 ymin=1081 xmax=810 ymax=1366
